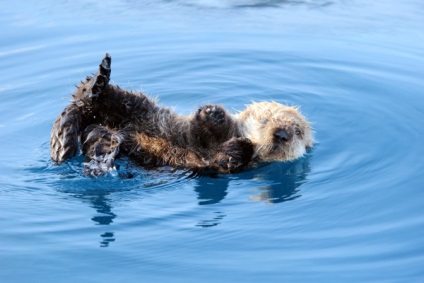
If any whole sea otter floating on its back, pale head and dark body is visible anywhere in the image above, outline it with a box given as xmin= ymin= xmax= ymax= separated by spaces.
xmin=50 ymin=54 xmax=313 ymax=176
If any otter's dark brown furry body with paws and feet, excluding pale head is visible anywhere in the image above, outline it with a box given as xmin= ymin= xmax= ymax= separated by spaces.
xmin=50 ymin=54 xmax=254 ymax=176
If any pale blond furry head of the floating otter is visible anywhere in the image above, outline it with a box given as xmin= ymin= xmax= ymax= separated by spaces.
xmin=238 ymin=102 xmax=313 ymax=161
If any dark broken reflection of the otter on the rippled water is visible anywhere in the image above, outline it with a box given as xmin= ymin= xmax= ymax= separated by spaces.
xmin=61 ymin=154 xmax=311 ymax=240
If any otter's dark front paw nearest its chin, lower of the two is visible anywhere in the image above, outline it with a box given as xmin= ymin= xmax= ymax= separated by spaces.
xmin=213 ymin=138 xmax=253 ymax=173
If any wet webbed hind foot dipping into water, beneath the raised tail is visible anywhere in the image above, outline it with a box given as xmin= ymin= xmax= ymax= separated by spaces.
xmin=82 ymin=125 xmax=124 ymax=177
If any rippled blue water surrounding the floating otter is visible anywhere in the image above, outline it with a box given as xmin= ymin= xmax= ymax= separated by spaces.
xmin=0 ymin=0 xmax=424 ymax=282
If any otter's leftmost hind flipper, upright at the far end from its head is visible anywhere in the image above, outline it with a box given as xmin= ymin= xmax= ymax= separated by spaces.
xmin=50 ymin=104 xmax=81 ymax=163
